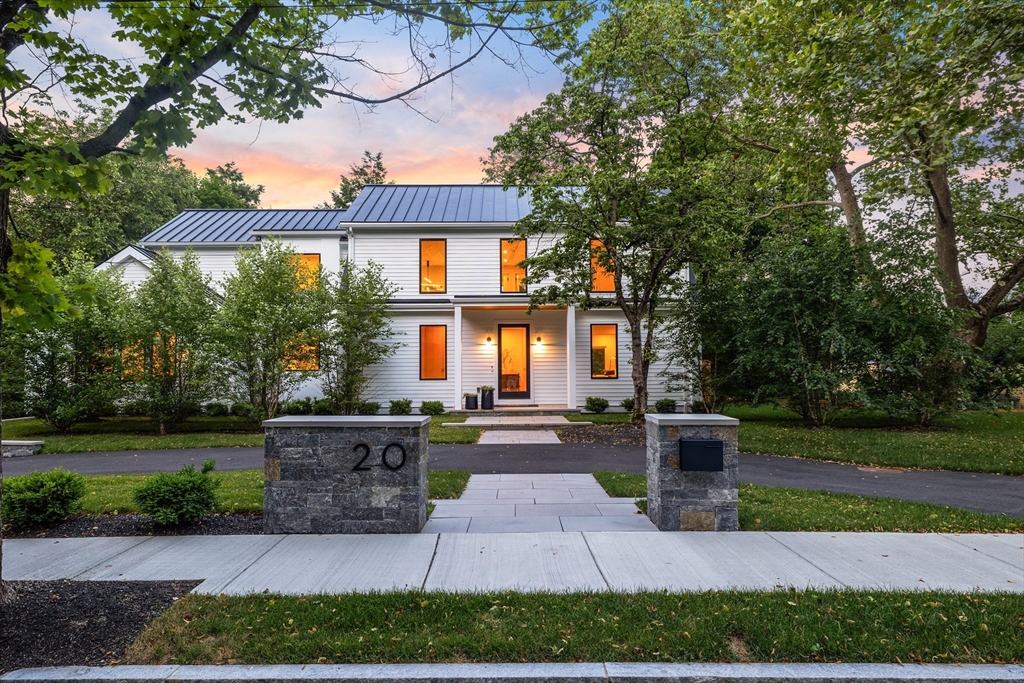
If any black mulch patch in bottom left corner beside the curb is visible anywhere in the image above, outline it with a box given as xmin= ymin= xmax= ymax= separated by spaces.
xmin=0 ymin=581 xmax=200 ymax=674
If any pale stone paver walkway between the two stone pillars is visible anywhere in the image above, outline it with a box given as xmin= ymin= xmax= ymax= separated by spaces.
xmin=423 ymin=475 xmax=656 ymax=533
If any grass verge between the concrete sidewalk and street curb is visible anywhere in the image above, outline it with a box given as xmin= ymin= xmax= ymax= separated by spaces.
xmin=124 ymin=590 xmax=1024 ymax=665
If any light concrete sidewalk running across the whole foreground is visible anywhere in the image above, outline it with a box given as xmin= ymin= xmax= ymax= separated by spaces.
xmin=3 ymin=531 xmax=1024 ymax=595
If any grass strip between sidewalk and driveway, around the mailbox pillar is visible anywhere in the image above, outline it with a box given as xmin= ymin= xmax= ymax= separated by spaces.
xmin=594 ymin=471 xmax=1024 ymax=533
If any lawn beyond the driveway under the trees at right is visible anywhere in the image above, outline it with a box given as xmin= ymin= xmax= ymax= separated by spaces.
xmin=726 ymin=407 xmax=1024 ymax=475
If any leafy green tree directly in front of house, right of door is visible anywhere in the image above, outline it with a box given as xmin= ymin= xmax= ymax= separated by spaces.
xmin=485 ymin=2 xmax=755 ymax=420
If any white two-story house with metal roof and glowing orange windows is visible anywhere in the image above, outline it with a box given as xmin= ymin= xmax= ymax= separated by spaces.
xmin=100 ymin=185 xmax=688 ymax=410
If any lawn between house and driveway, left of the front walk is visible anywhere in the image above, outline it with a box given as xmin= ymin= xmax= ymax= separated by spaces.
xmin=3 ymin=416 xmax=480 ymax=453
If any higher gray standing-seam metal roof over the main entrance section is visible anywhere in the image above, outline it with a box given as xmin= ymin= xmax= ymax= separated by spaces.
xmin=344 ymin=185 xmax=530 ymax=223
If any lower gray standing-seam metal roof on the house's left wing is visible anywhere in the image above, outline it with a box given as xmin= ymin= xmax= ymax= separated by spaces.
xmin=139 ymin=209 xmax=345 ymax=245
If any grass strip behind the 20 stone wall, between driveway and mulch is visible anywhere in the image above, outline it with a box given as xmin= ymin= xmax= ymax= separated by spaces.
xmin=71 ymin=470 xmax=469 ymax=515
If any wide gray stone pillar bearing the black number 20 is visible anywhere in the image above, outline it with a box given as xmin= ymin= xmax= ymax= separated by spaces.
xmin=263 ymin=415 xmax=430 ymax=533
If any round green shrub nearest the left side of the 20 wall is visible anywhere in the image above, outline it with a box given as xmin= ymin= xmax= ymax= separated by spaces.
xmin=134 ymin=460 xmax=220 ymax=526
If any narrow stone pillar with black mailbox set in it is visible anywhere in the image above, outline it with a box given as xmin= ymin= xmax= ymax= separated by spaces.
xmin=647 ymin=414 xmax=739 ymax=531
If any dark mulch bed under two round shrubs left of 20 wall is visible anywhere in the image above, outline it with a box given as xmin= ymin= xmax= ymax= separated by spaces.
xmin=4 ymin=513 xmax=263 ymax=539
